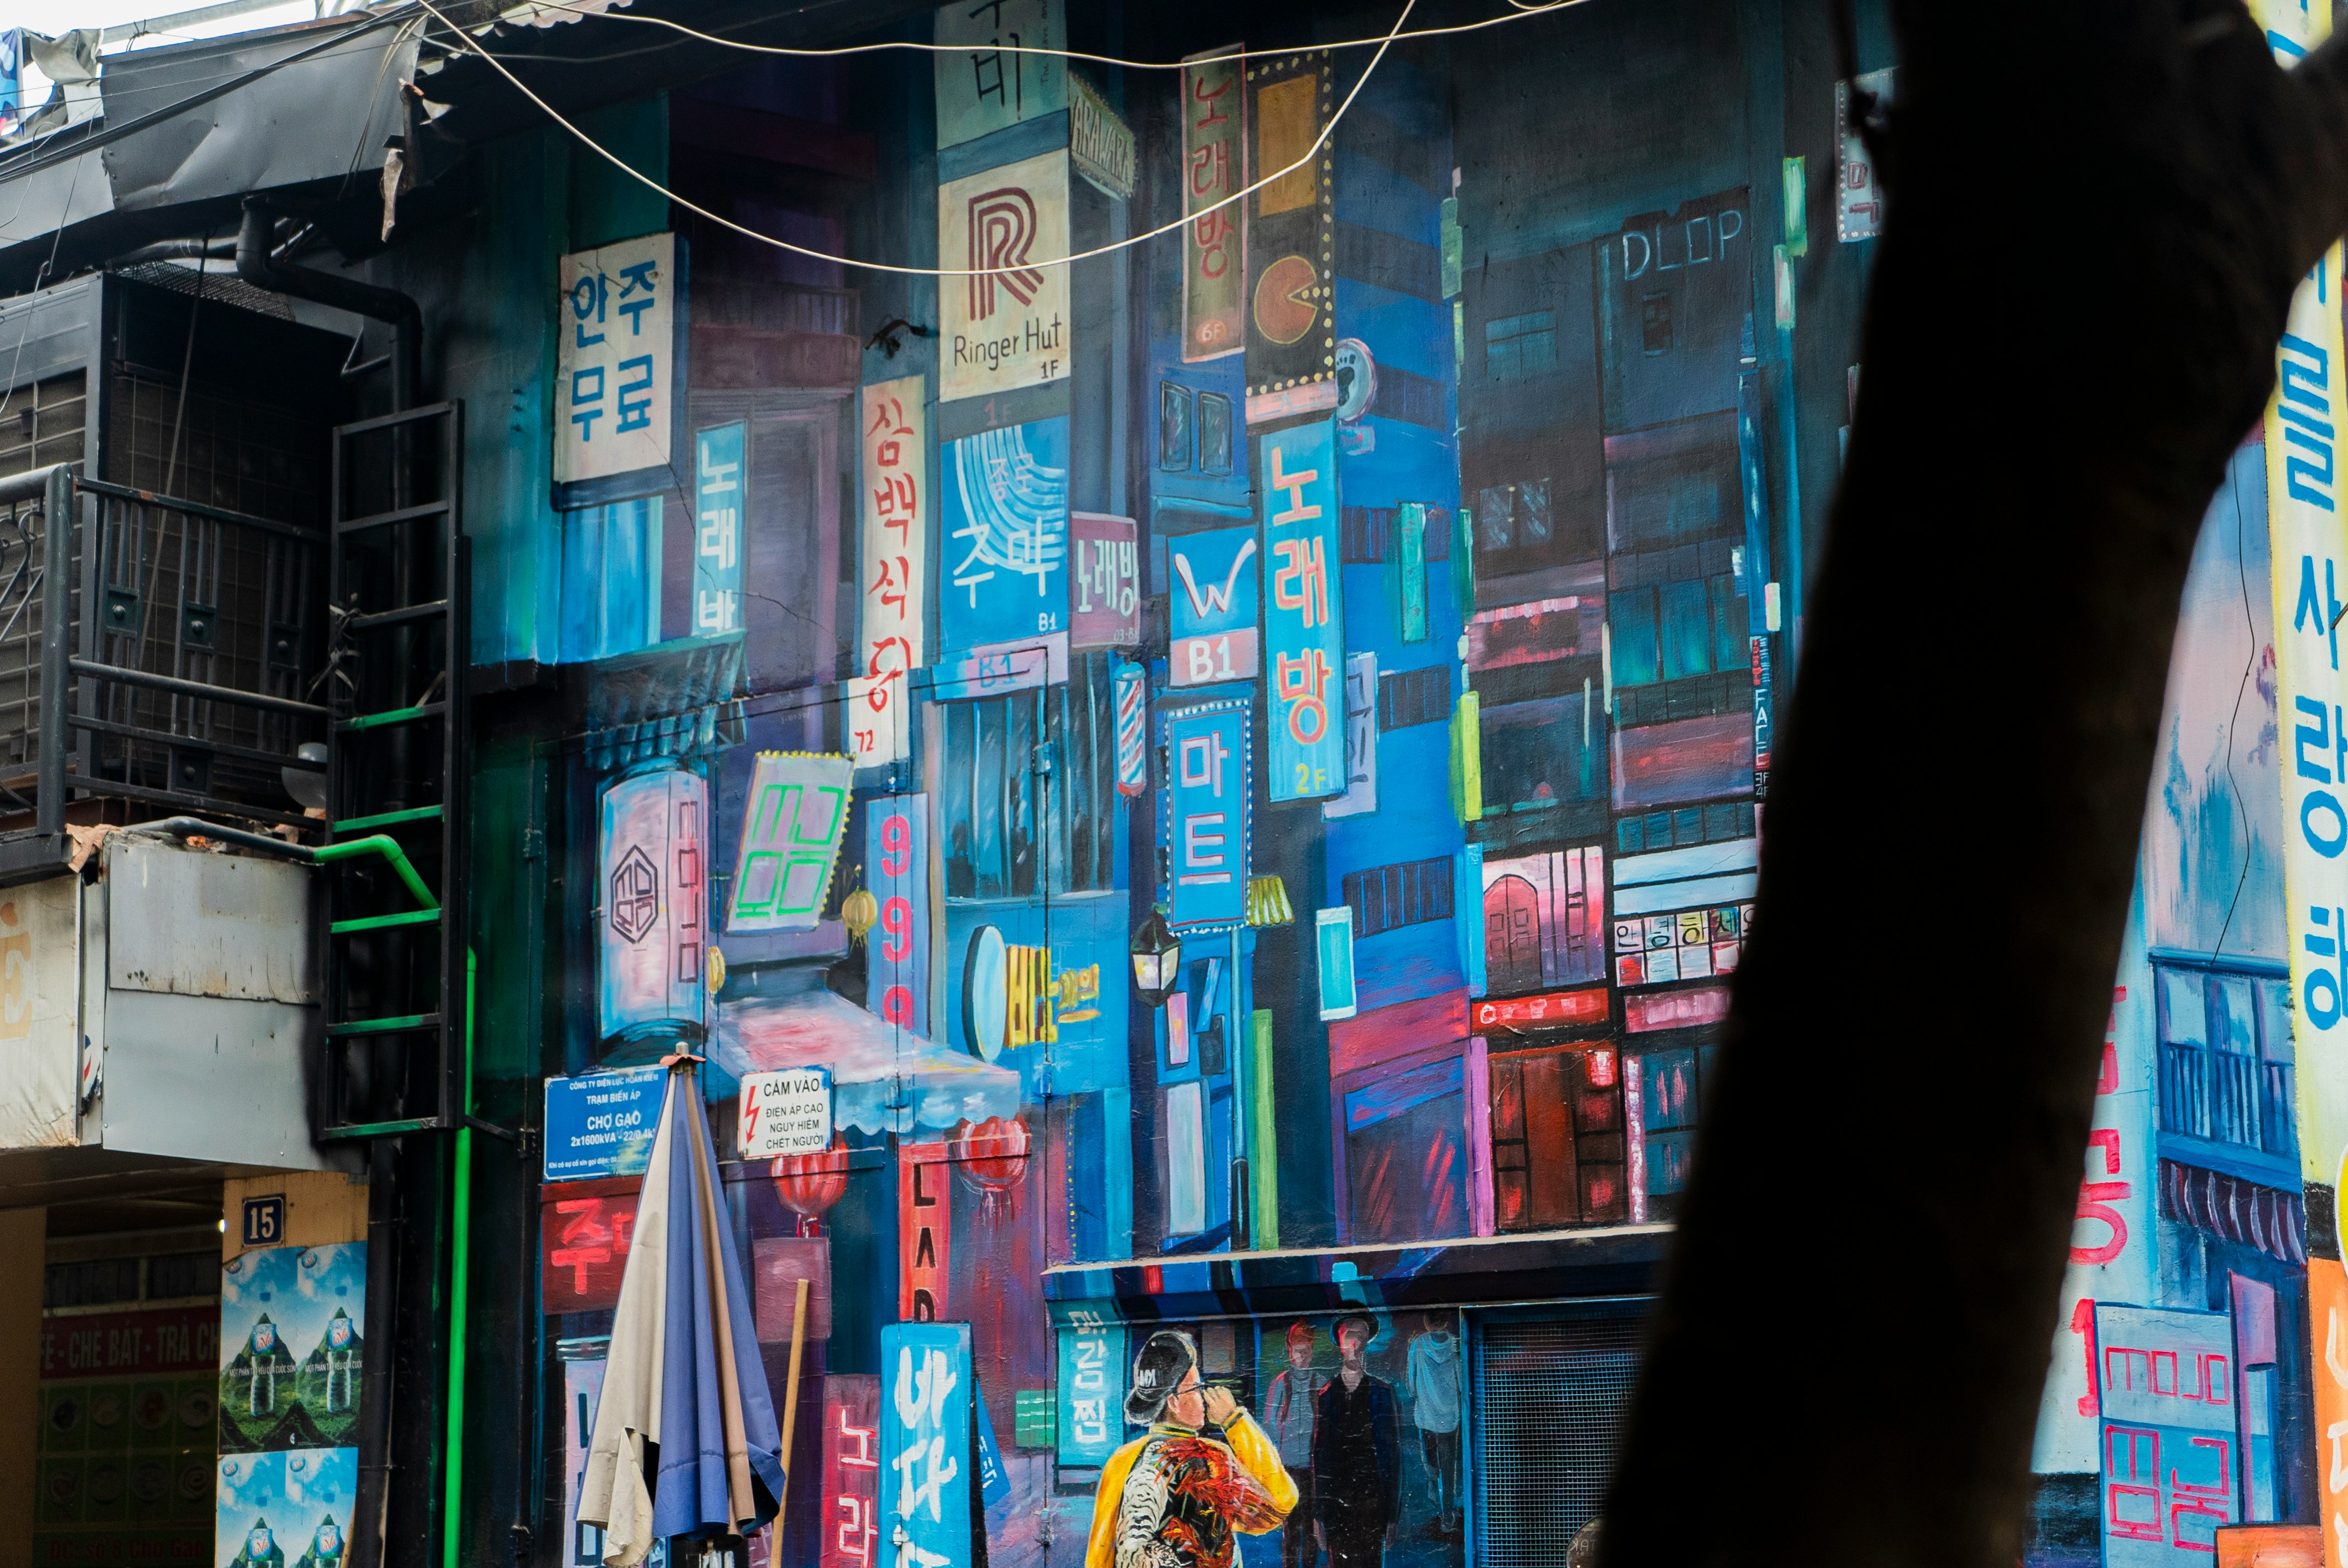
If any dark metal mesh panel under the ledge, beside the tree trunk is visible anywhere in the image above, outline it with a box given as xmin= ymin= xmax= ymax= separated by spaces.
xmin=1477 ymin=1317 xmax=1639 ymax=1568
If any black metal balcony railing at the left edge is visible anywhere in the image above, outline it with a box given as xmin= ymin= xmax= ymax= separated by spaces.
xmin=0 ymin=465 xmax=329 ymax=875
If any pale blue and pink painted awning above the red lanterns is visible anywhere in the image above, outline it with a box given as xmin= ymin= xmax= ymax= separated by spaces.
xmin=704 ymin=969 xmax=1019 ymax=1134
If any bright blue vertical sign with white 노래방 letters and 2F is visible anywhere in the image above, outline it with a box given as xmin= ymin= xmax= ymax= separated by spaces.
xmin=1256 ymin=420 xmax=1348 ymax=801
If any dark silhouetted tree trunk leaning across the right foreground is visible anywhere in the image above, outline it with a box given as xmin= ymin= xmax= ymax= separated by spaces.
xmin=1602 ymin=0 xmax=2348 ymax=1568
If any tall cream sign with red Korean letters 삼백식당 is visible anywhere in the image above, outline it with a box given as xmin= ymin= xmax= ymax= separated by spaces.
xmin=848 ymin=375 xmax=930 ymax=767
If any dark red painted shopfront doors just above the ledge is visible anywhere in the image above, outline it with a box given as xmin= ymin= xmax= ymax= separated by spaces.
xmin=1491 ymin=1045 xmax=1630 ymax=1230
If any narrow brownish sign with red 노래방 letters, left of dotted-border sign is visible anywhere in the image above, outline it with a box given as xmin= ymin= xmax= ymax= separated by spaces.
xmin=1181 ymin=45 xmax=1247 ymax=364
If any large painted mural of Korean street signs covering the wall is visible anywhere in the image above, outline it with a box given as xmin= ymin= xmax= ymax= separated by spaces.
xmin=495 ymin=0 xmax=2348 ymax=1568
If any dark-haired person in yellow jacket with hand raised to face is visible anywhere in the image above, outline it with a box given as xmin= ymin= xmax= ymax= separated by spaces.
xmin=1085 ymin=1329 xmax=1296 ymax=1568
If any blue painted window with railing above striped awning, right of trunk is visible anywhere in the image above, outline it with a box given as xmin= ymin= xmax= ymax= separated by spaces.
xmin=2153 ymin=964 xmax=2299 ymax=1174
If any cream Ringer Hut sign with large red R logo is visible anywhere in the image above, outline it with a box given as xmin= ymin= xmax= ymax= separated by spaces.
xmin=937 ymin=148 xmax=1068 ymax=401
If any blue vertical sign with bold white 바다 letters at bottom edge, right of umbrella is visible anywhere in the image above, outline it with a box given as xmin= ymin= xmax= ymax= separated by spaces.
xmin=878 ymin=1324 xmax=979 ymax=1568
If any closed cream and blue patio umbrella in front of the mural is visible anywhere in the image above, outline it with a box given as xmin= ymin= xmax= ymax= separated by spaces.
xmin=580 ymin=1056 xmax=782 ymax=1568
